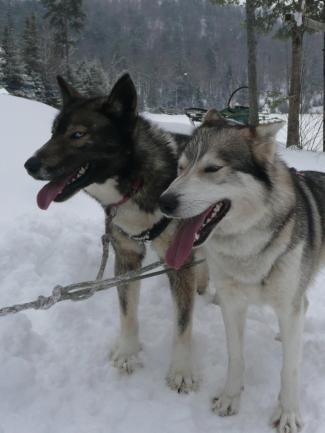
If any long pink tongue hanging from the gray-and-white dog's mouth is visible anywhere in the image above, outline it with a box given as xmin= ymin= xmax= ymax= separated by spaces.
xmin=165 ymin=208 xmax=211 ymax=269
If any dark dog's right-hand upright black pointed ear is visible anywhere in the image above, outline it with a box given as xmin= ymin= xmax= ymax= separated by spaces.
xmin=103 ymin=74 xmax=137 ymax=119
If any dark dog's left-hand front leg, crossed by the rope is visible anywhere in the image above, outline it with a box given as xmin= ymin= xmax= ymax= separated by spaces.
xmin=111 ymin=229 xmax=145 ymax=374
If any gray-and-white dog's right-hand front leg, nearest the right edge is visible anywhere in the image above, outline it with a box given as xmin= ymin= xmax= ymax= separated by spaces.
xmin=272 ymin=298 xmax=306 ymax=433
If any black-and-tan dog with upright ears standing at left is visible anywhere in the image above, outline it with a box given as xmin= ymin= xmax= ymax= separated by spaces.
xmin=25 ymin=74 xmax=208 ymax=392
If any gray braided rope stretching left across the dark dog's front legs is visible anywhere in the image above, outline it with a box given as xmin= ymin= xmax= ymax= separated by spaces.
xmin=0 ymin=259 xmax=204 ymax=317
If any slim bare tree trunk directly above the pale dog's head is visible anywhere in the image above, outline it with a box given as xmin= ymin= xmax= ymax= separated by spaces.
xmin=246 ymin=0 xmax=258 ymax=126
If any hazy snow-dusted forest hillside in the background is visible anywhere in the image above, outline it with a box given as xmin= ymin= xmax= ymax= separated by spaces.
xmin=0 ymin=0 xmax=323 ymax=112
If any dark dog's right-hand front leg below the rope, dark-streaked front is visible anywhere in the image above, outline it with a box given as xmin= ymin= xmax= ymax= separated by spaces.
xmin=166 ymin=268 xmax=198 ymax=393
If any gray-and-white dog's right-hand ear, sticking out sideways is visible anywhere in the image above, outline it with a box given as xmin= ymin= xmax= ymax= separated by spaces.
xmin=248 ymin=121 xmax=285 ymax=164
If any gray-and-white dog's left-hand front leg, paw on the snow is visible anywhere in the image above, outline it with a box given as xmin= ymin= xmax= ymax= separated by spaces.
xmin=212 ymin=289 xmax=247 ymax=416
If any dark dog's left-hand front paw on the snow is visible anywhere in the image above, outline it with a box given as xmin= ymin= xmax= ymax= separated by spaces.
xmin=110 ymin=344 xmax=143 ymax=374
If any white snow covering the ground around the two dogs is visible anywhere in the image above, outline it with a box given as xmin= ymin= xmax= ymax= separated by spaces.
xmin=0 ymin=95 xmax=325 ymax=433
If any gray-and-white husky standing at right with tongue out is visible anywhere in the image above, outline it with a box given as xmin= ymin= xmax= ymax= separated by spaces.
xmin=160 ymin=110 xmax=325 ymax=433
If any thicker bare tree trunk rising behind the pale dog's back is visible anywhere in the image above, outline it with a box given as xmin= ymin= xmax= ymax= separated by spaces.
xmin=287 ymin=23 xmax=303 ymax=147
